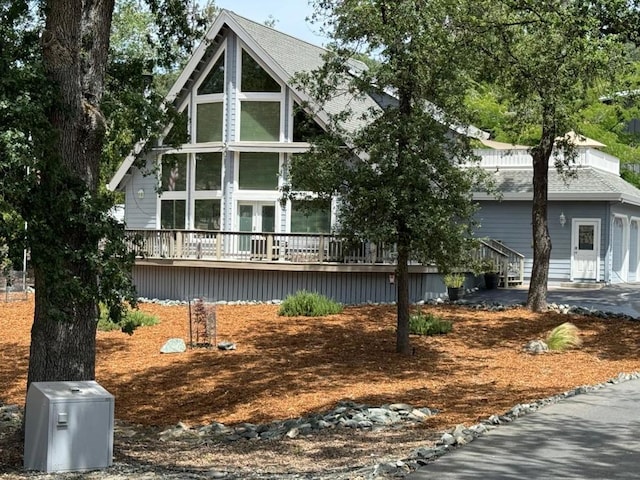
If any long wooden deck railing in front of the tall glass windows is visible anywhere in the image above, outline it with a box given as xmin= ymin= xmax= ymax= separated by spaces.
xmin=126 ymin=230 xmax=396 ymax=264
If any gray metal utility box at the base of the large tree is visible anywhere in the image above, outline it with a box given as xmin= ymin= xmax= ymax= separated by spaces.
xmin=24 ymin=381 xmax=114 ymax=472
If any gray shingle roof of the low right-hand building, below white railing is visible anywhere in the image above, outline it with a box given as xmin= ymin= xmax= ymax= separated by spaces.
xmin=476 ymin=167 xmax=640 ymax=205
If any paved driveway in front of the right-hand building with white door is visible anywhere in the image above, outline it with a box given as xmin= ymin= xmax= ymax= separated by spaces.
xmin=465 ymin=283 xmax=640 ymax=320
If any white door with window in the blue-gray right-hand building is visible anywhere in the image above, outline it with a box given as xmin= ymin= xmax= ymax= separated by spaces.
xmin=571 ymin=218 xmax=600 ymax=281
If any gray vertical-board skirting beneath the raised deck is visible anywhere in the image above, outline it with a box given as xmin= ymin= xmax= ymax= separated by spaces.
xmin=133 ymin=265 xmax=446 ymax=305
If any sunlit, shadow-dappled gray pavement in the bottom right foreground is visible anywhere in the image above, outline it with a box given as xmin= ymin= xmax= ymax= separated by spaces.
xmin=405 ymin=380 xmax=640 ymax=480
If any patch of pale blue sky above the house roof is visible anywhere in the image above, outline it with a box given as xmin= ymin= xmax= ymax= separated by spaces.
xmin=215 ymin=0 xmax=326 ymax=46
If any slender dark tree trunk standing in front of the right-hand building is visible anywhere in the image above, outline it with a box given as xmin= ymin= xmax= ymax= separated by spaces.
xmin=527 ymin=113 xmax=556 ymax=312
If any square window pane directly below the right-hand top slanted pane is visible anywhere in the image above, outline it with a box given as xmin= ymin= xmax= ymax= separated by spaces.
xmin=240 ymin=102 xmax=280 ymax=142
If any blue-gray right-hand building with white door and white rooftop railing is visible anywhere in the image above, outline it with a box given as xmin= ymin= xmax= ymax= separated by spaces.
xmin=474 ymin=136 xmax=640 ymax=285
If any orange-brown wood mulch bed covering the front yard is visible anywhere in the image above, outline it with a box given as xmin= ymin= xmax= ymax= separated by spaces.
xmin=0 ymin=299 xmax=640 ymax=429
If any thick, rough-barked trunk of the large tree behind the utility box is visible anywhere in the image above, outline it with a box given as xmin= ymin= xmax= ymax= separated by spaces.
xmin=27 ymin=0 xmax=114 ymax=385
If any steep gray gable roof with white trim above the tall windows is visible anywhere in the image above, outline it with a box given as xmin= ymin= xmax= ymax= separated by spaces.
xmin=107 ymin=10 xmax=488 ymax=190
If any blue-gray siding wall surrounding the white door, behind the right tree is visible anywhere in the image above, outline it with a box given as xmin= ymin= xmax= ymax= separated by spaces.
xmin=476 ymin=201 xmax=609 ymax=282
